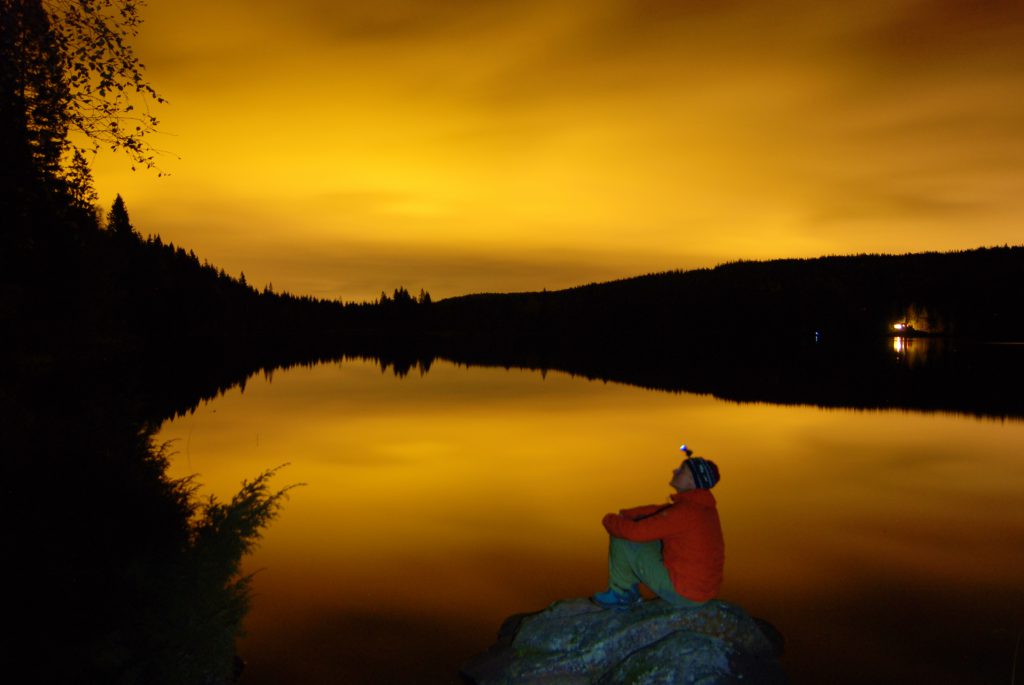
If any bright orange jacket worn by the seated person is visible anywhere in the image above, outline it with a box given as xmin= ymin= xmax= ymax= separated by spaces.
xmin=602 ymin=489 xmax=725 ymax=602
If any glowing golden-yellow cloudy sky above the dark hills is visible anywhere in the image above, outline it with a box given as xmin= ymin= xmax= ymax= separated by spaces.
xmin=94 ymin=0 xmax=1024 ymax=300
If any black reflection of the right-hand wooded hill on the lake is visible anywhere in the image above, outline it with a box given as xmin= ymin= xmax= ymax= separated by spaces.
xmin=364 ymin=335 xmax=1024 ymax=418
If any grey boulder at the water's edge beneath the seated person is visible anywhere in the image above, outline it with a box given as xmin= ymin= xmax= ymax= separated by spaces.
xmin=462 ymin=599 xmax=788 ymax=685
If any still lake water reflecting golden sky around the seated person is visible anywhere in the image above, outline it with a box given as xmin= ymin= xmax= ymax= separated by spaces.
xmin=159 ymin=360 xmax=1024 ymax=685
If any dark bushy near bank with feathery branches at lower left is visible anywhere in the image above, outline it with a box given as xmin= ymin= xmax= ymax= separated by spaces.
xmin=0 ymin=360 xmax=296 ymax=685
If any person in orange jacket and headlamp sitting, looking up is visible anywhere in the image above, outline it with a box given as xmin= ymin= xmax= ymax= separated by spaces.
xmin=592 ymin=445 xmax=725 ymax=609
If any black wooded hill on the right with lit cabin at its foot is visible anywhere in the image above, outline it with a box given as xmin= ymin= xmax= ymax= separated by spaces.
xmin=430 ymin=247 xmax=1024 ymax=349
